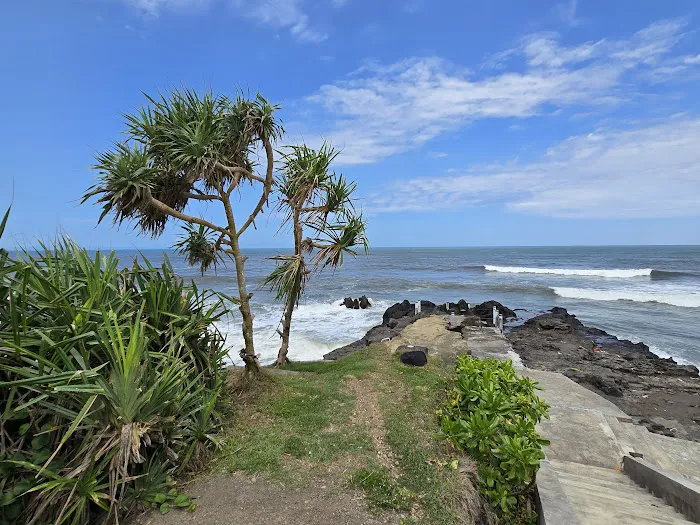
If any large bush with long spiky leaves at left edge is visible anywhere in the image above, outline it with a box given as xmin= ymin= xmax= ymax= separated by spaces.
xmin=0 ymin=240 xmax=225 ymax=525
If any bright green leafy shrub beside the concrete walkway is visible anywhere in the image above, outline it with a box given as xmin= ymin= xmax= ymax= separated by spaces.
xmin=440 ymin=356 xmax=549 ymax=523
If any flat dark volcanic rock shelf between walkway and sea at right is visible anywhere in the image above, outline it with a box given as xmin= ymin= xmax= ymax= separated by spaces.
xmin=506 ymin=308 xmax=700 ymax=441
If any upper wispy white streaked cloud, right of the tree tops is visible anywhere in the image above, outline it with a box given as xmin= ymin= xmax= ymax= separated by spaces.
xmin=302 ymin=20 xmax=694 ymax=164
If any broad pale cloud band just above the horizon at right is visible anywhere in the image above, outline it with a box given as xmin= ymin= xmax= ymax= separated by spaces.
xmin=368 ymin=118 xmax=700 ymax=218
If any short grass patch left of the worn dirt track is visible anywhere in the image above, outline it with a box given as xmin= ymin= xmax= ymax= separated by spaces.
xmin=214 ymin=356 xmax=378 ymax=478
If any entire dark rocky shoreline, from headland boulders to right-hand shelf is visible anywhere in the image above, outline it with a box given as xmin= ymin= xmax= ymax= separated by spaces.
xmin=323 ymin=300 xmax=700 ymax=441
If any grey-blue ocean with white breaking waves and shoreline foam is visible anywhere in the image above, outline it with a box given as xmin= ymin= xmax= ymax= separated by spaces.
xmin=119 ymin=246 xmax=700 ymax=366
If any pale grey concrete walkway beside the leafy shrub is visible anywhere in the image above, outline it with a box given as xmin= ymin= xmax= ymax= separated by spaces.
xmin=465 ymin=328 xmax=700 ymax=525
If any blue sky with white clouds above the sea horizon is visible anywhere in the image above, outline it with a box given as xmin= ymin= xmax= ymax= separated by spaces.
xmin=0 ymin=0 xmax=700 ymax=248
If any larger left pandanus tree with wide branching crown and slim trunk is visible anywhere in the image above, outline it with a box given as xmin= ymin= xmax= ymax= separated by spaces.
xmin=83 ymin=90 xmax=283 ymax=376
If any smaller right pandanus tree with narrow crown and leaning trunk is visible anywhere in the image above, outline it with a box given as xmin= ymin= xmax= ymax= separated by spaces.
xmin=262 ymin=143 xmax=368 ymax=366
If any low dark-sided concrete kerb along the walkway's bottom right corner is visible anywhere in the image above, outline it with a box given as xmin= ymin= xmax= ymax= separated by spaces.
xmin=622 ymin=456 xmax=700 ymax=523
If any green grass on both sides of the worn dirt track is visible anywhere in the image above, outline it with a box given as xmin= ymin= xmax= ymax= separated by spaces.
xmin=214 ymin=345 xmax=482 ymax=525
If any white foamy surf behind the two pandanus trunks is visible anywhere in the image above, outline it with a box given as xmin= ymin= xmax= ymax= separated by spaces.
xmin=219 ymin=298 xmax=390 ymax=365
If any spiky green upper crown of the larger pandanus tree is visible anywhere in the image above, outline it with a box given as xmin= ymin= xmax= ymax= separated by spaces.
xmin=83 ymin=89 xmax=283 ymax=237
